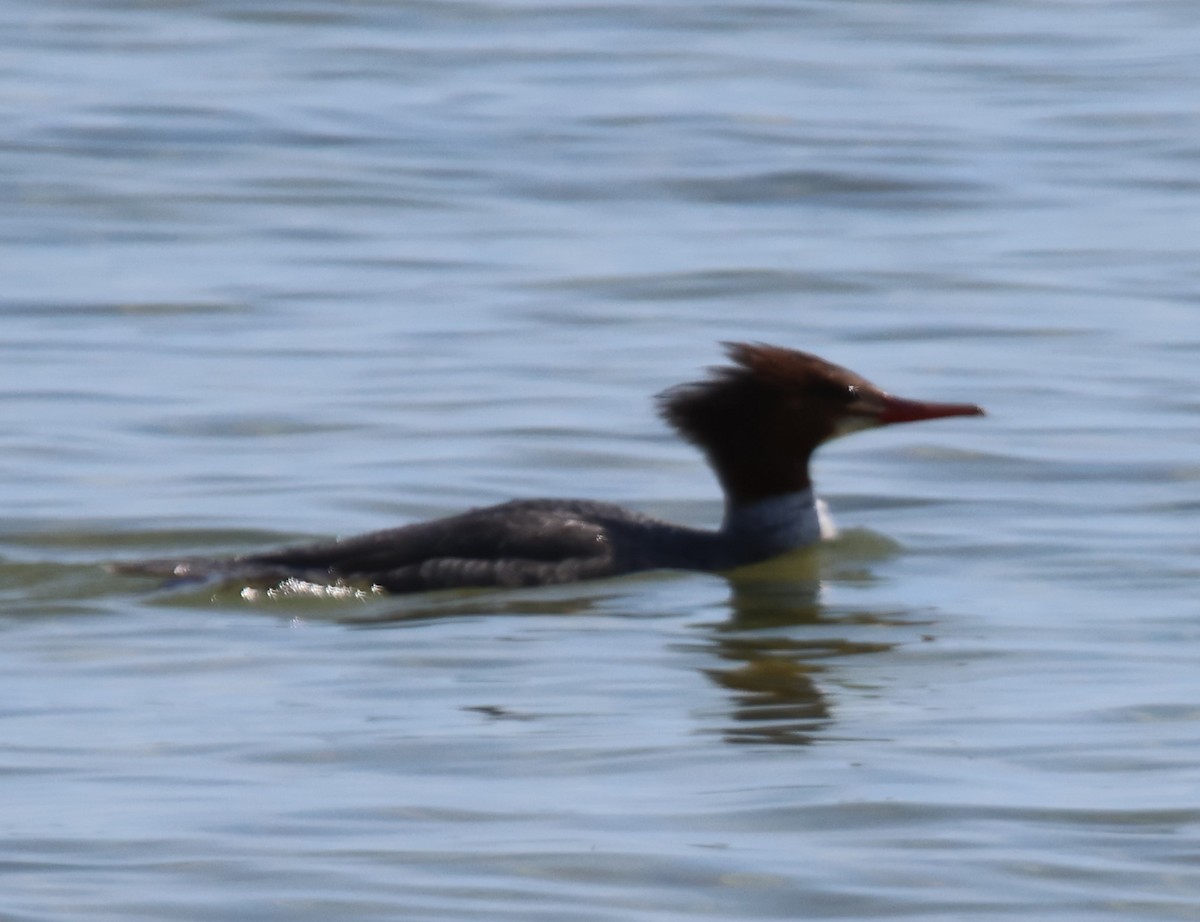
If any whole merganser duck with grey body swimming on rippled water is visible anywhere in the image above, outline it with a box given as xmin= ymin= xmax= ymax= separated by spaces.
xmin=114 ymin=342 xmax=983 ymax=593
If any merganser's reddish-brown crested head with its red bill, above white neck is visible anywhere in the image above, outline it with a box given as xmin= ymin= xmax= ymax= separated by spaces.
xmin=659 ymin=342 xmax=983 ymax=504
